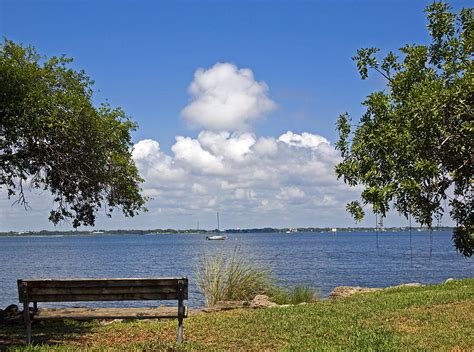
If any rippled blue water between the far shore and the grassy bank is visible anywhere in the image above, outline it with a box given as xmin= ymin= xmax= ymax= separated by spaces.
xmin=0 ymin=232 xmax=474 ymax=308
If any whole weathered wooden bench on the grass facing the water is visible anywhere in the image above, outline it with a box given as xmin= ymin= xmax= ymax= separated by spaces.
xmin=18 ymin=277 xmax=188 ymax=344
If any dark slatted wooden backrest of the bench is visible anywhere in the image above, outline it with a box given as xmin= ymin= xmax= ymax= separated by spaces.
xmin=18 ymin=277 xmax=188 ymax=303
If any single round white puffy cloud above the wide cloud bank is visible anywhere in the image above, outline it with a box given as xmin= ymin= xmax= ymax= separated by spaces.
xmin=181 ymin=63 xmax=276 ymax=131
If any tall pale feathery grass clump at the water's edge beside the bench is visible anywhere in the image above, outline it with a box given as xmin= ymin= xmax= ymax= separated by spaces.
xmin=195 ymin=250 xmax=274 ymax=307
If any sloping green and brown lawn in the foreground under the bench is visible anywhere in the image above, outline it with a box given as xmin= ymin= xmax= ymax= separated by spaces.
xmin=0 ymin=279 xmax=474 ymax=351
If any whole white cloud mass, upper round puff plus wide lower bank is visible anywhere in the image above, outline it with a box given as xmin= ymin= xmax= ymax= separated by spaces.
xmin=133 ymin=69 xmax=348 ymax=227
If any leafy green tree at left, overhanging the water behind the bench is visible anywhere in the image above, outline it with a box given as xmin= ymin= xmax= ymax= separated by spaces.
xmin=0 ymin=39 xmax=146 ymax=227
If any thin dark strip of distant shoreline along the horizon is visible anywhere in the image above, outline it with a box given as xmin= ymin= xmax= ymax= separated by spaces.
xmin=0 ymin=226 xmax=454 ymax=237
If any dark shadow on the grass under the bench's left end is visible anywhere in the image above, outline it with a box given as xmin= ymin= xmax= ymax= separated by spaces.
xmin=0 ymin=320 xmax=98 ymax=351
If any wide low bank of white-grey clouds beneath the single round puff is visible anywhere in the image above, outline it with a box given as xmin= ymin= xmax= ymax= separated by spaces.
xmin=130 ymin=131 xmax=356 ymax=227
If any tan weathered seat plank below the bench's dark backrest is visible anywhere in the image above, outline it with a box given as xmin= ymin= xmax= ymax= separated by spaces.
xmin=34 ymin=307 xmax=188 ymax=320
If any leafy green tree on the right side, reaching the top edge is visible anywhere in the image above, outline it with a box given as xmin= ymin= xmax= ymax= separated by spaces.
xmin=335 ymin=2 xmax=474 ymax=256
